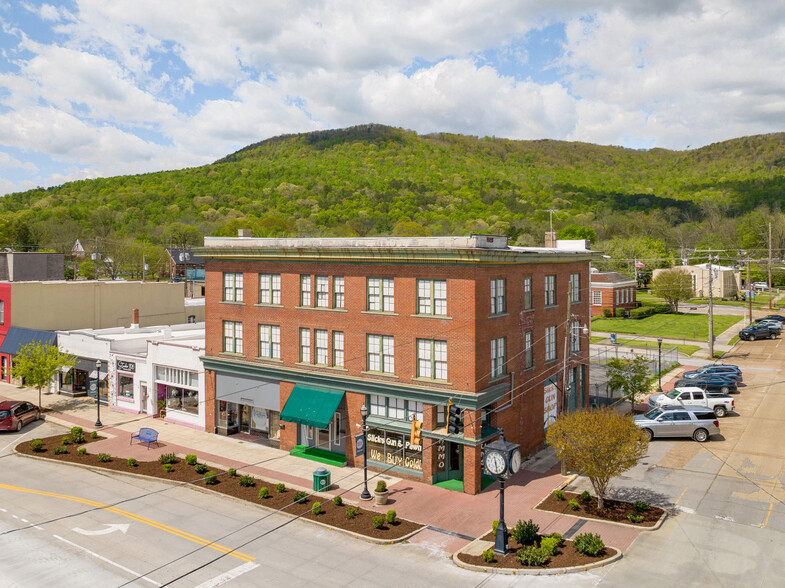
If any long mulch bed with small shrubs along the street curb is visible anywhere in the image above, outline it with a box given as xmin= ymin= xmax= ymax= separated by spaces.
xmin=16 ymin=434 xmax=423 ymax=541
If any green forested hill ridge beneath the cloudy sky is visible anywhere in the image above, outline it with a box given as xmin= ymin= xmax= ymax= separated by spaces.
xmin=0 ymin=125 xmax=785 ymax=258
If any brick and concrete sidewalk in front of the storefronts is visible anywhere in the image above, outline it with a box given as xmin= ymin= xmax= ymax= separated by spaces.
xmin=0 ymin=383 xmax=640 ymax=553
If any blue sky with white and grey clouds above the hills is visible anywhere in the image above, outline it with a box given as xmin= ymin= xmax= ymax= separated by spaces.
xmin=0 ymin=0 xmax=785 ymax=195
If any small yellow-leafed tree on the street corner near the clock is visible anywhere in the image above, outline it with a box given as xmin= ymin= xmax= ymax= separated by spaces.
xmin=545 ymin=408 xmax=649 ymax=509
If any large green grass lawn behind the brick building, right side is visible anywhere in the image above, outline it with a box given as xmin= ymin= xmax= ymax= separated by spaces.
xmin=591 ymin=314 xmax=742 ymax=341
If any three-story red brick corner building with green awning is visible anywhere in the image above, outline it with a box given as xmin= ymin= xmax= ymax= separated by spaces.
xmin=198 ymin=236 xmax=594 ymax=494
